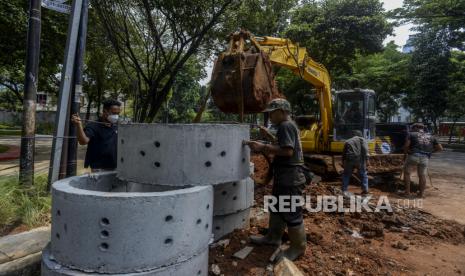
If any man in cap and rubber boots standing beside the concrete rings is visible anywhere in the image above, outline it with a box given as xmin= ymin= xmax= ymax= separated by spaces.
xmin=246 ymin=99 xmax=307 ymax=260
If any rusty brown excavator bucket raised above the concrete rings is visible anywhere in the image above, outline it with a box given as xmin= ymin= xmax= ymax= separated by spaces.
xmin=211 ymin=32 xmax=279 ymax=114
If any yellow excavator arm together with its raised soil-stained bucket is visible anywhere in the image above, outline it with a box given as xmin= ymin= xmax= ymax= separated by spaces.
xmin=212 ymin=30 xmax=333 ymax=151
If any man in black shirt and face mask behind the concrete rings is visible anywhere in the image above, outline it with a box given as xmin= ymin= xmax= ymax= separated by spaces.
xmin=71 ymin=100 xmax=121 ymax=172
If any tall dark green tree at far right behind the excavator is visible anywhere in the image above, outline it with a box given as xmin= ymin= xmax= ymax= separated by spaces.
xmin=405 ymin=28 xmax=450 ymax=130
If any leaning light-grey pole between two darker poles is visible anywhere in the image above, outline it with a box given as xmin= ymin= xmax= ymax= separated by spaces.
xmin=48 ymin=0 xmax=82 ymax=188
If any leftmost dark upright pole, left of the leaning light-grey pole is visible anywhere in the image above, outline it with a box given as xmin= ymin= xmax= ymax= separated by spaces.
xmin=19 ymin=0 xmax=42 ymax=185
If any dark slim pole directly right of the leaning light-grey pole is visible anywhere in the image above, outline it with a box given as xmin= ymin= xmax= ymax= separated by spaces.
xmin=66 ymin=0 xmax=89 ymax=177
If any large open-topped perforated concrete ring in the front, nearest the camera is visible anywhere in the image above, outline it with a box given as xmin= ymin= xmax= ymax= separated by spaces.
xmin=51 ymin=173 xmax=213 ymax=273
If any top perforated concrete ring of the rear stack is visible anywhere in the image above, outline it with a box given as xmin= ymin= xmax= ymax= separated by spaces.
xmin=117 ymin=124 xmax=250 ymax=186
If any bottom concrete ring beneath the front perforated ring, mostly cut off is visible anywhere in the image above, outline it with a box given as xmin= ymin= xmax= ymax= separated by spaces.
xmin=42 ymin=247 xmax=208 ymax=276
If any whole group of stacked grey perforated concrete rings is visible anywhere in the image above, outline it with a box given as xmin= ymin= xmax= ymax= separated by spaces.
xmin=42 ymin=124 xmax=254 ymax=275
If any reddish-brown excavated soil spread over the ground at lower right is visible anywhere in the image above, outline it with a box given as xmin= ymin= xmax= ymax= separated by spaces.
xmin=209 ymin=156 xmax=465 ymax=275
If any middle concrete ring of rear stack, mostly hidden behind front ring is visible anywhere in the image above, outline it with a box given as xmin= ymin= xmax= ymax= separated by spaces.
xmin=213 ymin=177 xmax=254 ymax=216
